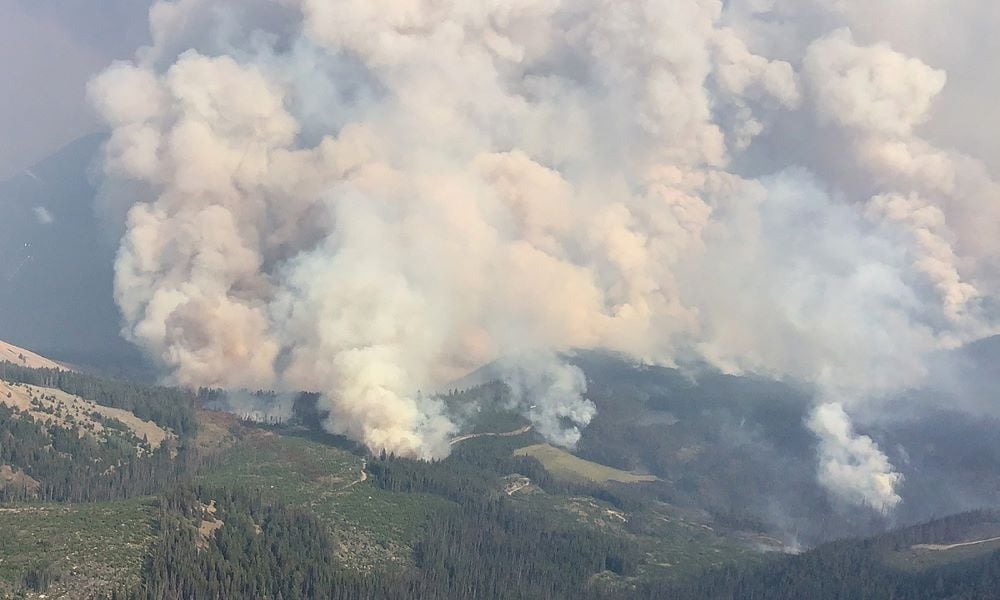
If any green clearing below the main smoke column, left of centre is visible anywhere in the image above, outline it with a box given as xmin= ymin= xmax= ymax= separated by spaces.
xmin=199 ymin=431 xmax=452 ymax=571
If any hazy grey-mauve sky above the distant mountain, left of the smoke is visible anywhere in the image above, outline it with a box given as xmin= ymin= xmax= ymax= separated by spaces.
xmin=0 ymin=0 xmax=150 ymax=179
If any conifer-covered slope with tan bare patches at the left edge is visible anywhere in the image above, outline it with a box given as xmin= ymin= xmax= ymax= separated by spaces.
xmin=0 ymin=363 xmax=196 ymax=502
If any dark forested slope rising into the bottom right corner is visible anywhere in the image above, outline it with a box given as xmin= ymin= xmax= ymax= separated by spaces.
xmin=605 ymin=511 xmax=1000 ymax=600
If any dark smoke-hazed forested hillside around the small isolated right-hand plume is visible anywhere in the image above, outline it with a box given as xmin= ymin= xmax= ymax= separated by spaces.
xmin=574 ymin=350 xmax=1000 ymax=547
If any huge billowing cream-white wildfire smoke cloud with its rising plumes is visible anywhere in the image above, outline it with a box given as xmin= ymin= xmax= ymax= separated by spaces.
xmin=91 ymin=0 xmax=1000 ymax=508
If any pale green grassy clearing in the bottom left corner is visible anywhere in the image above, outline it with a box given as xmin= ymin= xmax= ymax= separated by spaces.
xmin=0 ymin=499 xmax=156 ymax=598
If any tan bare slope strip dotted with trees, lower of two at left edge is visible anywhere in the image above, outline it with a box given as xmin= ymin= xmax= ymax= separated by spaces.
xmin=0 ymin=381 xmax=174 ymax=448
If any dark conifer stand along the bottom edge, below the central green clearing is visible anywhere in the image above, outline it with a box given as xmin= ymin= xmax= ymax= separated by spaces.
xmin=130 ymin=487 xmax=634 ymax=600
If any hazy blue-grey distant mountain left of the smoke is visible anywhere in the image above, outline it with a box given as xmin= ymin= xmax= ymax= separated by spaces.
xmin=0 ymin=134 xmax=144 ymax=374
